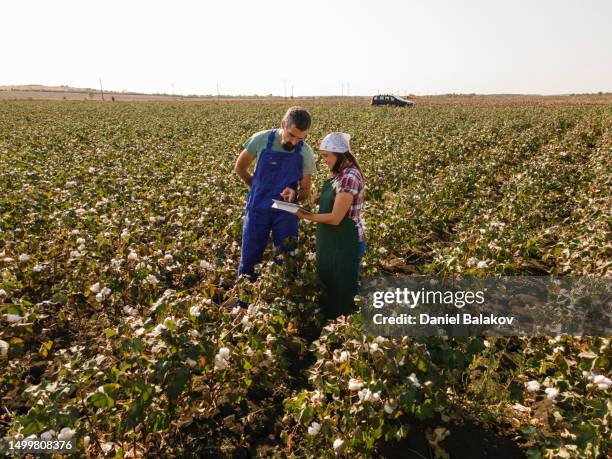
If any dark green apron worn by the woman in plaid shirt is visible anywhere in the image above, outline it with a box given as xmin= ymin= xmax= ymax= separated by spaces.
xmin=317 ymin=178 xmax=359 ymax=319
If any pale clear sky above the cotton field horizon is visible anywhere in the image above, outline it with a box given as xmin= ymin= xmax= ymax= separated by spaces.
xmin=0 ymin=0 xmax=612 ymax=96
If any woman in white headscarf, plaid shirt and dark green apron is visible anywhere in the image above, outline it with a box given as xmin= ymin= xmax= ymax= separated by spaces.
xmin=297 ymin=132 xmax=365 ymax=319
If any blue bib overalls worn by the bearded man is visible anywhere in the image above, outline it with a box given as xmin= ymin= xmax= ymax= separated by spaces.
xmin=238 ymin=129 xmax=304 ymax=280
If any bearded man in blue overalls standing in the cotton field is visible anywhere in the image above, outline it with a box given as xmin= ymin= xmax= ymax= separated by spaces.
xmin=234 ymin=107 xmax=316 ymax=280
